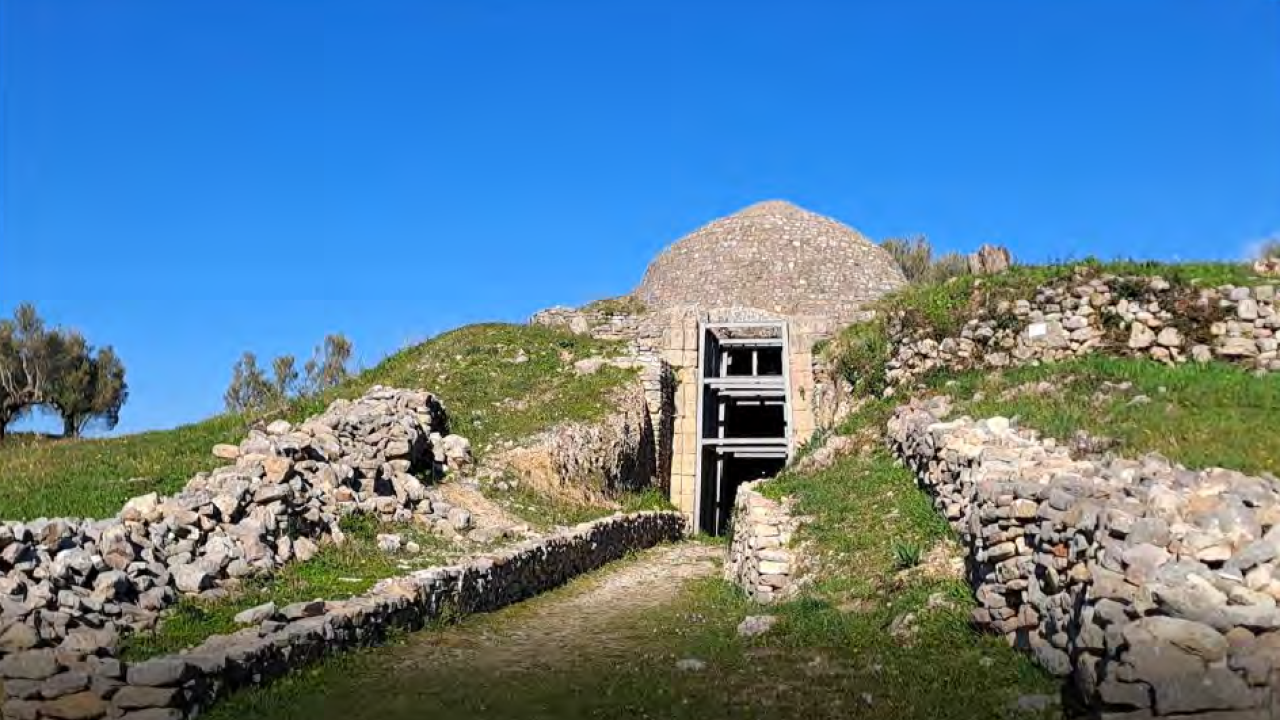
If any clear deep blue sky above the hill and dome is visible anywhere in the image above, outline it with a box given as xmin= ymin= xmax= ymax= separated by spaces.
xmin=0 ymin=0 xmax=1280 ymax=430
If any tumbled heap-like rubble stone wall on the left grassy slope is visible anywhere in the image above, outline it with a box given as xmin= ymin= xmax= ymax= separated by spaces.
xmin=0 ymin=387 xmax=470 ymax=657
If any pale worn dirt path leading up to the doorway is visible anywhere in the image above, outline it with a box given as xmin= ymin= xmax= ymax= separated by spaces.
xmin=384 ymin=543 xmax=724 ymax=673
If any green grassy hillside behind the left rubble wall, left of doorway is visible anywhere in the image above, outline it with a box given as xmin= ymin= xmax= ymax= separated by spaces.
xmin=0 ymin=324 xmax=630 ymax=519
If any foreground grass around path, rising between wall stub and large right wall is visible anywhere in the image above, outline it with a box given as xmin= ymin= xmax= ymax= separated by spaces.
xmin=199 ymin=452 xmax=1057 ymax=720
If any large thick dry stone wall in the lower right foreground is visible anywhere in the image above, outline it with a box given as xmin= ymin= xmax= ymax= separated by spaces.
xmin=888 ymin=398 xmax=1280 ymax=720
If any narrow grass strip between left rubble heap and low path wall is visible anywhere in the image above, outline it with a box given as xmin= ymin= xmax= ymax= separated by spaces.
xmin=123 ymin=512 xmax=454 ymax=661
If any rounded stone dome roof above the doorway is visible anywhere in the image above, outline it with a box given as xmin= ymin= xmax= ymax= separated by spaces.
xmin=635 ymin=200 xmax=906 ymax=320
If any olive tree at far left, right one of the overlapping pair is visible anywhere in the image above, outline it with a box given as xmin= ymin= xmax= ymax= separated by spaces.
xmin=45 ymin=332 xmax=129 ymax=437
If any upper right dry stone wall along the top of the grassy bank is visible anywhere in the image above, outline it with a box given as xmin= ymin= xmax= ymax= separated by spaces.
xmin=887 ymin=272 xmax=1280 ymax=384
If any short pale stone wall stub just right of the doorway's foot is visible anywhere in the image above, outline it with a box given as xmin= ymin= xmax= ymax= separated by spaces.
xmin=724 ymin=480 xmax=801 ymax=603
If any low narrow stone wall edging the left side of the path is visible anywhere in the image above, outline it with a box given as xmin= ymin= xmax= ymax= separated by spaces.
xmin=0 ymin=512 xmax=685 ymax=720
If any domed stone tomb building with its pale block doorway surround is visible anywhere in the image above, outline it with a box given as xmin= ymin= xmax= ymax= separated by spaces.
xmin=530 ymin=201 xmax=906 ymax=514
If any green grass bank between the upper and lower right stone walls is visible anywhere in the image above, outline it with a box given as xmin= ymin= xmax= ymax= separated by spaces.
xmin=933 ymin=356 xmax=1280 ymax=474
